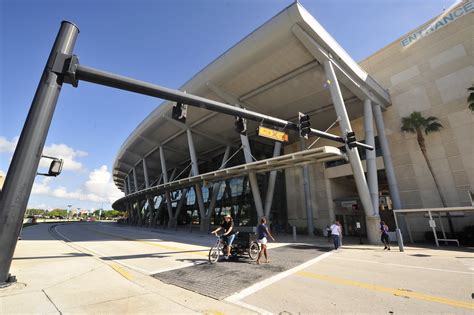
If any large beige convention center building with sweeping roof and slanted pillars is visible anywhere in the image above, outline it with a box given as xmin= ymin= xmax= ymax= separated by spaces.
xmin=113 ymin=0 xmax=474 ymax=242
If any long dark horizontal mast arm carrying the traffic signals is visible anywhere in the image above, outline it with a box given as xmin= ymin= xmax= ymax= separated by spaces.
xmin=62 ymin=56 xmax=373 ymax=150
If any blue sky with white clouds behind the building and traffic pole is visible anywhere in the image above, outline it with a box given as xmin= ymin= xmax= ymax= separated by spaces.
xmin=0 ymin=0 xmax=454 ymax=210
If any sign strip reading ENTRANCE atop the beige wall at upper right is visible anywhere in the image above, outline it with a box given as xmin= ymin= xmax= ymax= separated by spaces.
xmin=400 ymin=0 xmax=474 ymax=47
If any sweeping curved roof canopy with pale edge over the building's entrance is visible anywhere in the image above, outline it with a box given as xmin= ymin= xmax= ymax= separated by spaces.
xmin=113 ymin=3 xmax=390 ymax=190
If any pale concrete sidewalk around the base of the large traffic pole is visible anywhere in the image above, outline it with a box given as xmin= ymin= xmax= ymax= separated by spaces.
xmin=0 ymin=224 xmax=249 ymax=314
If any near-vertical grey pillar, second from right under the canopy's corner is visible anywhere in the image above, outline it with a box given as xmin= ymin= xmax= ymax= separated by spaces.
xmin=364 ymin=99 xmax=379 ymax=216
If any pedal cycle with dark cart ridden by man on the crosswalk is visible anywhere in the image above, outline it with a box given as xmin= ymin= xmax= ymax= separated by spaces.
xmin=208 ymin=232 xmax=260 ymax=264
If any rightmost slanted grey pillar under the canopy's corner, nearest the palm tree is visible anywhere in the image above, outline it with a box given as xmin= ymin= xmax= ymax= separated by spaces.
xmin=373 ymin=104 xmax=402 ymax=209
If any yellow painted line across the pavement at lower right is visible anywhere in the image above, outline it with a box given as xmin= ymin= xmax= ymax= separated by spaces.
xmin=296 ymin=271 xmax=474 ymax=310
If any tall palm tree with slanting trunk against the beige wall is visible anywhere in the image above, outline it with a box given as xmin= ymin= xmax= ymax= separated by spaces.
xmin=401 ymin=112 xmax=456 ymax=236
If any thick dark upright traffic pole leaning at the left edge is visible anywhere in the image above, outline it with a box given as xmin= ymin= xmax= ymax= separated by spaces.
xmin=0 ymin=21 xmax=79 ymax=287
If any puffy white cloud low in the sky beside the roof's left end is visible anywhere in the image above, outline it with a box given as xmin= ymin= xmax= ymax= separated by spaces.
xmin=32 ymin=165 xmax=123 ymax=203
